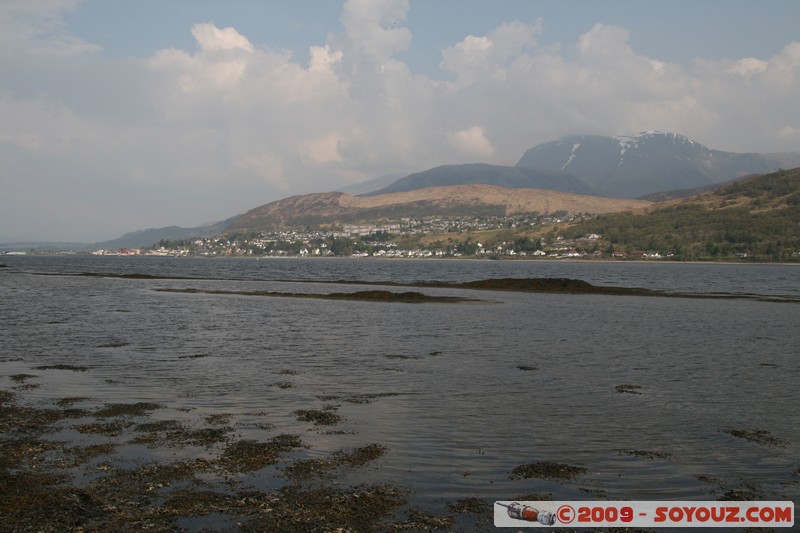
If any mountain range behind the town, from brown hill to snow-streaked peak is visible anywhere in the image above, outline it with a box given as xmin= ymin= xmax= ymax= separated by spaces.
xmin=4 ymin=131 xmax=800 ymax=249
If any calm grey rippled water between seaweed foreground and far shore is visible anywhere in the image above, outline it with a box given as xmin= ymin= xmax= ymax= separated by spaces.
xmin=0 ymin=257 xmax=800 ymax=512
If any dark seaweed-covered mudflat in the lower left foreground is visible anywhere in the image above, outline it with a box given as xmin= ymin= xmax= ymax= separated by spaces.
xmin=0 ymin=384 xmax=500 ymax=532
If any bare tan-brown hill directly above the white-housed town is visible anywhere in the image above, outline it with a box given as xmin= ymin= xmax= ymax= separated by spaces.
xmin=227 ymin=185 xmax=651 ymax=232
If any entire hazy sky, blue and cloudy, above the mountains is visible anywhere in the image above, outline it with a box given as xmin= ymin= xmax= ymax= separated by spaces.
xmin=0 ymin=0 xmax=800 ymax=242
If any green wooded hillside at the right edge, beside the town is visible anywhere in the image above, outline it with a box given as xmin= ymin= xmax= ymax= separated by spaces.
xmin=561 ymin=168 xmax=800 ymax=261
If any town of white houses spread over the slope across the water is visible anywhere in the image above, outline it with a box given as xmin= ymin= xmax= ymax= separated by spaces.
xmin=81 ymin=212 xmax=672 ymax=259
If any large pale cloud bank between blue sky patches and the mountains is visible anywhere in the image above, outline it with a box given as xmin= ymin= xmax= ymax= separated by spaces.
xmin=0 ymin=0 xmax=800 ymax=239
